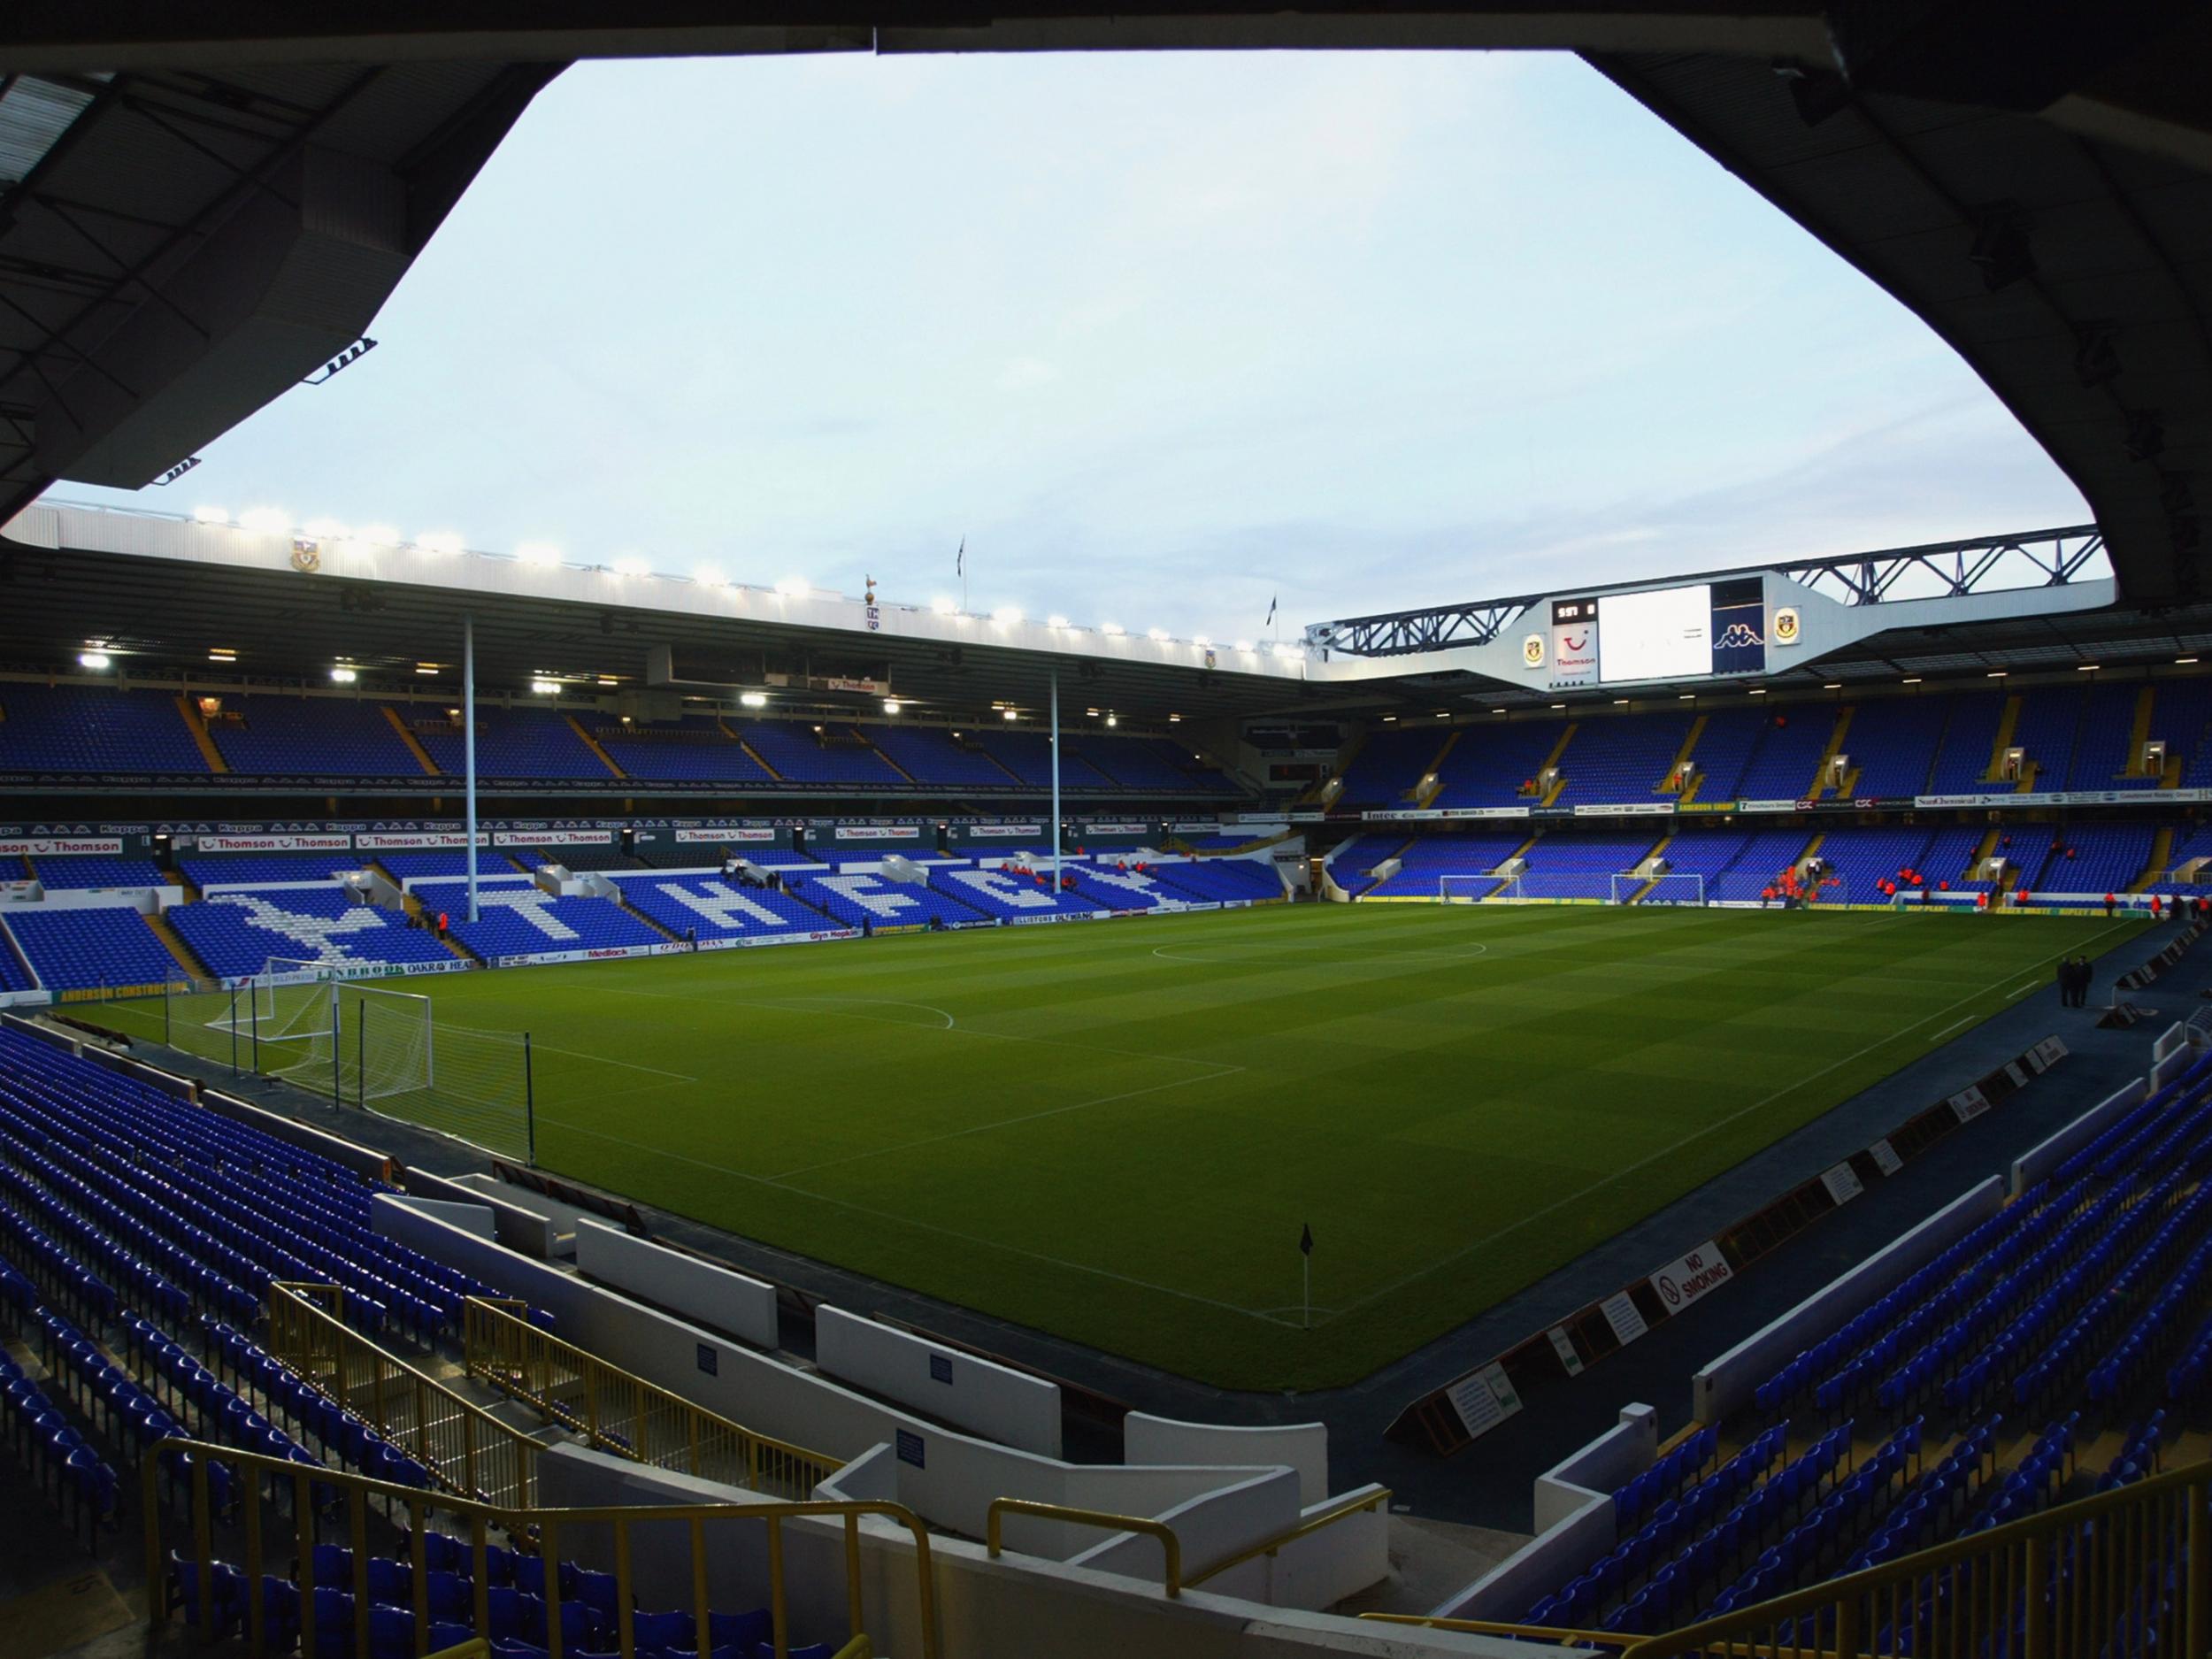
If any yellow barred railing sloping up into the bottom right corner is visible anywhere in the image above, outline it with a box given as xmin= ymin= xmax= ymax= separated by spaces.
xmin=1628 ymin=1463 xmax=2212 ymax=1659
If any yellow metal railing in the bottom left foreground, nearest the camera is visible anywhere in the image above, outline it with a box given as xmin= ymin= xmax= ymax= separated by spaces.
xmin=142 ymin=1440 xmax=938 ymax=1659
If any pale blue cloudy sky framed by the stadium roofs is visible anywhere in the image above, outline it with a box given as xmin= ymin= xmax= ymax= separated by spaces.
xmin=53 ymin=53 xmax=2088 ymax=641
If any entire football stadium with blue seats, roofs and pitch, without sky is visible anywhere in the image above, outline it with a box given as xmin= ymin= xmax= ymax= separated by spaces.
xmin=0 ymin=3 xmax=2212 ymax=1659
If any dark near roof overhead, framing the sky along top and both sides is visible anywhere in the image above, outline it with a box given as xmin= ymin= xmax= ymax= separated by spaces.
xmin=0 ymin=0 xmax=2212 ymax=619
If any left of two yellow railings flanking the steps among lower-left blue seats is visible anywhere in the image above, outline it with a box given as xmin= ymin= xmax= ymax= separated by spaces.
xmin=268 ymin=1283 xmax=544 ymax=1509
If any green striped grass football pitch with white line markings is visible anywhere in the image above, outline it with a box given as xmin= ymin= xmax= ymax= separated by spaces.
xmin=142 ymin=905 xmax=2137 ymax=1389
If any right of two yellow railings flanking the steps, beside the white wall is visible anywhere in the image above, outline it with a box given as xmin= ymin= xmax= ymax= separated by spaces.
xmin=463 ymin=1296 xmax=843 ymax=1498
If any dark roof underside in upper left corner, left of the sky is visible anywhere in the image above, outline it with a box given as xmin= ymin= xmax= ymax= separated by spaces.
xmin=0 ymin=61 xmax=556 ymax=518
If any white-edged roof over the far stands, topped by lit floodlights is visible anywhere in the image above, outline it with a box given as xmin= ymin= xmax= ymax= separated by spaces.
xmin=12 ymin=504 xmax=2212 ymax=721
